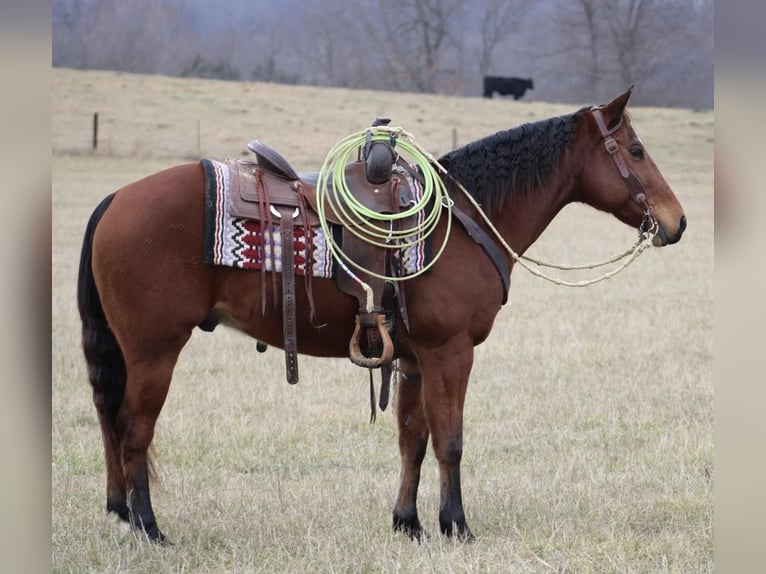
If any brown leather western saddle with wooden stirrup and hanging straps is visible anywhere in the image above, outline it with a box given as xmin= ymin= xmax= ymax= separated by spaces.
xmin=227 ymin=118 xmax=418 ymax=408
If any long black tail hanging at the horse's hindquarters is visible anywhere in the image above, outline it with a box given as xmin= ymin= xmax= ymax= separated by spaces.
xmin=77 ymin=194 xmax=126 ymax=433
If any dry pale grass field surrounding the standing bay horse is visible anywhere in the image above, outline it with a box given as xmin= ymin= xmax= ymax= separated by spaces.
xmin=52 ymin=70 xmax=714 ymax=573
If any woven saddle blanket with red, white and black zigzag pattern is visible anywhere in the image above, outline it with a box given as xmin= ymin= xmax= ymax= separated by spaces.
xmin=200 ymin=159 xmax=431 ymax=278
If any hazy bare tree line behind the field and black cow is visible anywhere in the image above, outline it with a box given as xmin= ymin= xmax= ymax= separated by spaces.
xmin=53 ymin=0 xmax=713 ymax=108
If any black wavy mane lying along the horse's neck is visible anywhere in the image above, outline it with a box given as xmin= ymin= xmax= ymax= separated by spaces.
xmin=439 ymin=108 xmax=588 ymax=212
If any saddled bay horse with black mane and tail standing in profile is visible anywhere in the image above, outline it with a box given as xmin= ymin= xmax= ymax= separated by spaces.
xmin=78 ymin=88 xmax=686 ymax=542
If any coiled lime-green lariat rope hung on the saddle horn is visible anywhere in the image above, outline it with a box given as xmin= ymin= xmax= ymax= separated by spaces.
xmin=316 ymin=126 xmax=452 ymax=286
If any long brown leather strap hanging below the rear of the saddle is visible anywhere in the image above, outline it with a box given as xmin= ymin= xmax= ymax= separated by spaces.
xmin=279 ymin=208 xmax=298 ymax=385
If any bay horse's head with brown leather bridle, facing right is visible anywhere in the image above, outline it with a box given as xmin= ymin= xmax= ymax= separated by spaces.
xmin=578 ymin=87 xmax=686 ymax=246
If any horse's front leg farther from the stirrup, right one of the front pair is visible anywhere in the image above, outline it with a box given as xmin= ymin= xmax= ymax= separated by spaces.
xmin=418 ymin=340 xmax=474 ymax=540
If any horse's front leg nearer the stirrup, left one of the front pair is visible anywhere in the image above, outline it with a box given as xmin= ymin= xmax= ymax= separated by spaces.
xmin=394 ymin=359 xmax=428 ymax=540
